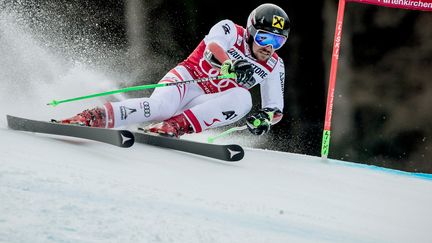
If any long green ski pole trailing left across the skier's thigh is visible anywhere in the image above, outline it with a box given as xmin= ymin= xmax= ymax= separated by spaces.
xmin=47 ymin=73 xmax=236 ymax=106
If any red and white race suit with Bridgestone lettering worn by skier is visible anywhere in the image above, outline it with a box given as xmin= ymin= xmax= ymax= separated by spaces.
xmin=105 ymin=20 xmax=285 ymax=132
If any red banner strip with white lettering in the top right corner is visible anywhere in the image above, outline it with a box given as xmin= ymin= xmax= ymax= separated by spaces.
xmin=347 ymin=0 xmax=432 ymax=11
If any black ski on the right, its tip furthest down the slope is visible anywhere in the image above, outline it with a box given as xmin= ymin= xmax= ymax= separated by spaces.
xmin=133 ymin=132 xmax=244 ymax=161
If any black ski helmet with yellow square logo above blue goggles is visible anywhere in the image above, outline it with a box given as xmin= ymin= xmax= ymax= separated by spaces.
xmin=246 ymin=3 xmax=291 ymax=45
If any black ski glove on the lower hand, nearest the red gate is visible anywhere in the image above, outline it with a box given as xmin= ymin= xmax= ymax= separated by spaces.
xmin=246 ymin=108 xmax=274 ymax=135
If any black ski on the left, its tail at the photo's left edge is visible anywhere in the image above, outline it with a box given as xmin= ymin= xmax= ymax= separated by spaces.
xmin=6 ymin=115 xmax=135 ymax=148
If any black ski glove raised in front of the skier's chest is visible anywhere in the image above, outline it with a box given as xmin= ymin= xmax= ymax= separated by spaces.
xmin=221 ymin=59 xmax=255 ymax=89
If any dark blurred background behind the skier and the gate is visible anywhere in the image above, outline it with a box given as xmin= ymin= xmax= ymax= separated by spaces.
xmin=0 ymin=0 xmax=432 ymax=173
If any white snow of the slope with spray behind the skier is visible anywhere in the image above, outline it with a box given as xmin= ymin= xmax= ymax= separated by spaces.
xmin=0 ymin=6 xmax=432 ymax=243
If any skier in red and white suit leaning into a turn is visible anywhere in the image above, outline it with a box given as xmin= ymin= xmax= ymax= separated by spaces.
xmin=61 ymin=3 xmax=290 ymax=137
